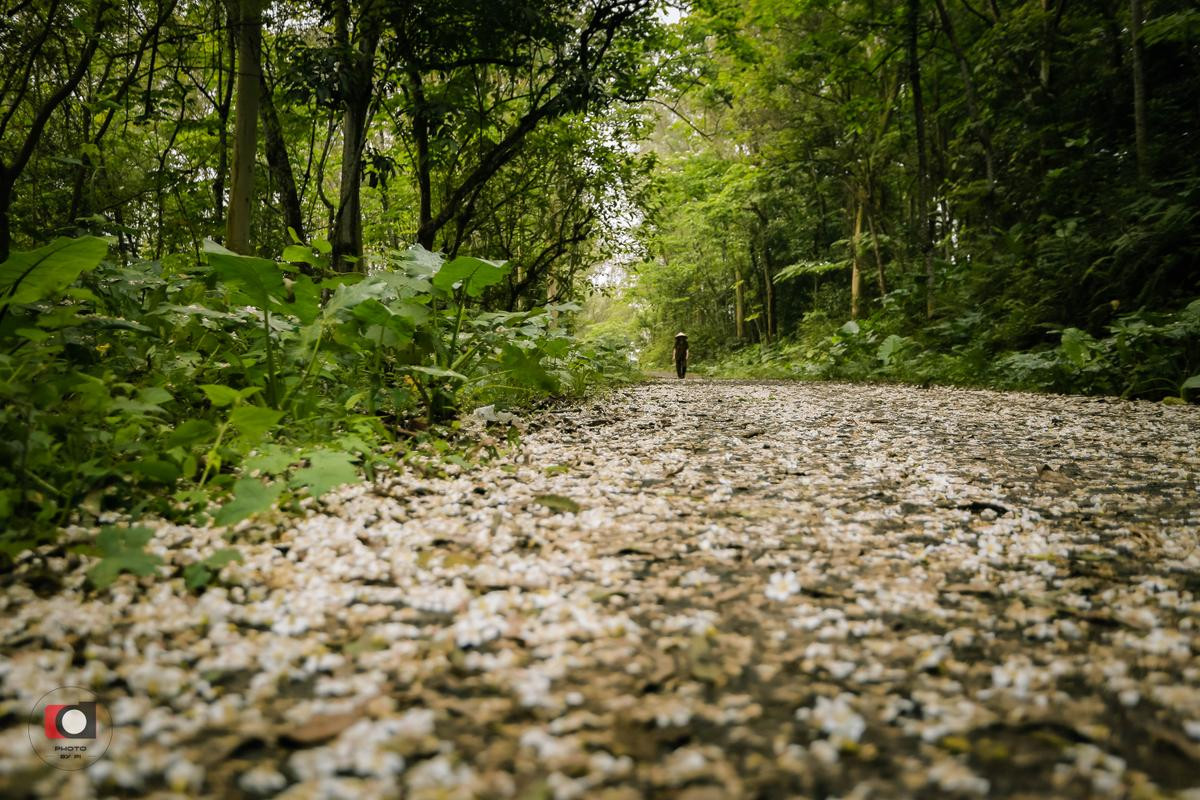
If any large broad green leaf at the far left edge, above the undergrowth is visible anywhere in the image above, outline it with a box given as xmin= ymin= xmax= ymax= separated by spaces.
xmin=0 ymin=236 xmax=108 ymax=308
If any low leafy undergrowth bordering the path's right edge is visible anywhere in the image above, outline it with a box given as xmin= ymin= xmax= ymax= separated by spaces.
xmin=694 ymin=300 xmax=1200 ymax=403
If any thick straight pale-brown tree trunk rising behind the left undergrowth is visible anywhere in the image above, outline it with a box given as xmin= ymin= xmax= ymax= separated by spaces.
xmin=226 ymin=0 xmax=263 ymax=253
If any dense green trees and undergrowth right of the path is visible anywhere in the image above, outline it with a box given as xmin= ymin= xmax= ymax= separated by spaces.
xmin=632 ymin=0 xmax=1200 ymax=398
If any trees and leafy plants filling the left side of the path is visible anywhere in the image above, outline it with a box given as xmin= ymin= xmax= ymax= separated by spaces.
xmin=0 ymin=0 xmax=664 ymax=561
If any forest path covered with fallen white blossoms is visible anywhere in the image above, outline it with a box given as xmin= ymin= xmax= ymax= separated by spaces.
xmin=0 ymin=379 xmax=1200 ymax=800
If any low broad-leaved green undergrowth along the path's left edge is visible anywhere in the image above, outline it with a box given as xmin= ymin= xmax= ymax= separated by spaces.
xmin=0 ymin=236 xmax=632 ymax=566
